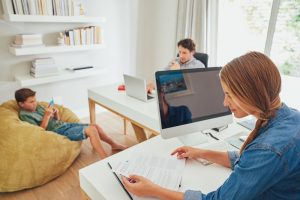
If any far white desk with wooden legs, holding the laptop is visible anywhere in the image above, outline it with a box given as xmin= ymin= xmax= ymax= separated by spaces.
xmin=88 ymin=84 xmax=160 ymax=142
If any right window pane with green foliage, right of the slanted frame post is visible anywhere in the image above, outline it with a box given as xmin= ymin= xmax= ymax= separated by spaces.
xmin=270 ymin=0 xmax=300 ymax=77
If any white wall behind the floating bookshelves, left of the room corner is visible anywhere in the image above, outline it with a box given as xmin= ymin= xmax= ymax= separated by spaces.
xmin=0 ymin=0 xmax=137 ymax=117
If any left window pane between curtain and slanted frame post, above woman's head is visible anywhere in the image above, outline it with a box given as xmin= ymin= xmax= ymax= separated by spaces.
xmin=216 ymin=0 xmax=272 ymax=66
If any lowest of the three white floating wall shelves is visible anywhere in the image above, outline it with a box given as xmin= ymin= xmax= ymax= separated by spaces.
xmin=15 ymin=68 xmax=106 ymax=87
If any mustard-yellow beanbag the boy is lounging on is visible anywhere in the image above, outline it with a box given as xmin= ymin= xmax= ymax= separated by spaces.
xmin=0 ymin=100 xmax=81 ymax=192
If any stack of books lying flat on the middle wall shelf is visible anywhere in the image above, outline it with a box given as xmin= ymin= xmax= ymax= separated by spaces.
xmin=11 ymin=34 xmax=44 ymax=48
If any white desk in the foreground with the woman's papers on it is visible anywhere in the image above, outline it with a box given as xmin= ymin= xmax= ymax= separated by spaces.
xmin=79 ymin=124 xmax=245 ymax=200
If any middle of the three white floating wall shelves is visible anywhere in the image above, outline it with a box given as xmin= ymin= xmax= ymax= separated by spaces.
xmin=9 ymin=44 xmax=105 ymax=56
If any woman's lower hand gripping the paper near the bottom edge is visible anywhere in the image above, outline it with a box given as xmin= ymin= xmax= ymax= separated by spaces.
xmin=122 ymin=175 xmax=160 ymax=196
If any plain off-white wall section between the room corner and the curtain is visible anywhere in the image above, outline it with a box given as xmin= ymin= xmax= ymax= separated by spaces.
xmin=136 ymin=0 xmax=178 ymax=81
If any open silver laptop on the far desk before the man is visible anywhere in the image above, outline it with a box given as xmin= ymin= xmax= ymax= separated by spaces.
xmin=123 ymin=74 xmax=154 ymax=102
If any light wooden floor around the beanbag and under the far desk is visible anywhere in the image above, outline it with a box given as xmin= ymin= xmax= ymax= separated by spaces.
xmin=0 ymin=112 xmax=137 ymax=200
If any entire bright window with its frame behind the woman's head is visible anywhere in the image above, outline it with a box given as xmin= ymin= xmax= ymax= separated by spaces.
xmin=208 ymin=0 xmax=300 ymax=110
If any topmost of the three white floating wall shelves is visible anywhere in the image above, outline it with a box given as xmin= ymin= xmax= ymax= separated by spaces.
xmin=3 ymin=14 xmax=106 ymax=23
